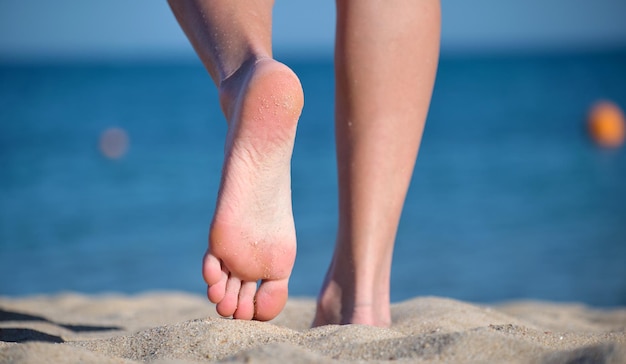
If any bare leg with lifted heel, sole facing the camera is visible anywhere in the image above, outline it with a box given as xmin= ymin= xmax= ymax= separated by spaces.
xmin=170 ymin=0 xmax=303 ymax=320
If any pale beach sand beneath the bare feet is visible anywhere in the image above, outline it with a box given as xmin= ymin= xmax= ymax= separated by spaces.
xmin=0 ymin=292 xmax=626 ymax=363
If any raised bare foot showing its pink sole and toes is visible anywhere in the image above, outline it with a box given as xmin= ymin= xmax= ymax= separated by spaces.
xmin=202 ymin=58 xmax=304 ymax=321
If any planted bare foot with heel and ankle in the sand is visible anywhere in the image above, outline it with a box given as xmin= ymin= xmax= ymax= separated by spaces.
xmin=312 ymin=252 xmax=391 ymax=327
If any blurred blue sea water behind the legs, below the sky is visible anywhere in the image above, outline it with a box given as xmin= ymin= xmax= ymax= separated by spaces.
xmin=0 ymin=52 xmax=626 ymax=306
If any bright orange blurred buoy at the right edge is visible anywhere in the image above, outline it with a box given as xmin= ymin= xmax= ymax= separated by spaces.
xmin=587 ymin=101 xmax=626 ymax=148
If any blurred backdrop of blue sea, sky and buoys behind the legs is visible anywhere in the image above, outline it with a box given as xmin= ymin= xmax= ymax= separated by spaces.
xmin=0 ymin=0 xmax=626 ymax=306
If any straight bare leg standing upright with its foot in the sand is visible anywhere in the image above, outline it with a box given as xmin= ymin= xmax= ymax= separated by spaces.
xmin=313 ymin=0 xmax=440 ymax=326
